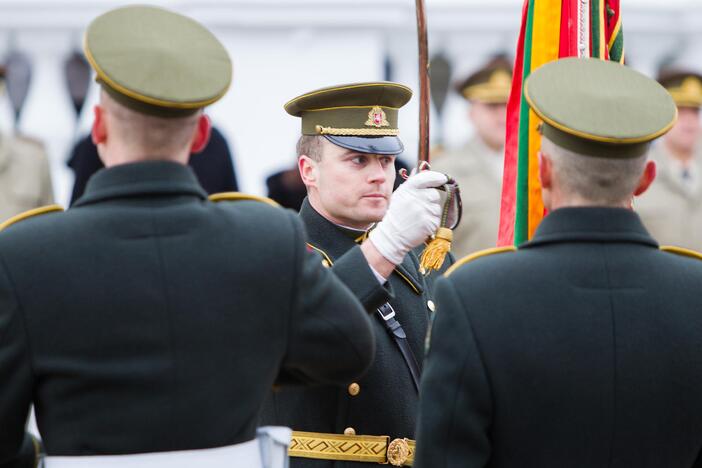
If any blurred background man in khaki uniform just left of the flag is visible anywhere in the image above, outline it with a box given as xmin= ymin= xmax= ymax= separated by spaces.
xmin=432 ymin=58 xmax=512 ymax=257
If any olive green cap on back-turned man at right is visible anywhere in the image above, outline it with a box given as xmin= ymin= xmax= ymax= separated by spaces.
xmin=524 ymin=58 xmax=677 ymax=158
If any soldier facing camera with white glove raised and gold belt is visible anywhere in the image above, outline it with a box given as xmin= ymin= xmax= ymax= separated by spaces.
xmin=264 ymin=82 xmax=447 ymax=468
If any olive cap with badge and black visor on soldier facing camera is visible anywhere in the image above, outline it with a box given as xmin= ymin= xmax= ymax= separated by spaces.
xmin=285 ymin=81 xmax=412 ymax=155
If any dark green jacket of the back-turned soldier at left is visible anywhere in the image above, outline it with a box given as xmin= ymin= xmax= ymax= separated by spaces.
xmin=0 ymin=162 xmax=374 ymax=468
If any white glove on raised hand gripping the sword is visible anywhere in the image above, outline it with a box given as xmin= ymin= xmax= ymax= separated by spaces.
xmin=369 ymin=171 xmax=447 ymax=265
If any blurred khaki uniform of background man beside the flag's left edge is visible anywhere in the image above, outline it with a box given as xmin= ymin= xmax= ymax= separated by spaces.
xmin=432 ymin=136 xmax=504 ymax=258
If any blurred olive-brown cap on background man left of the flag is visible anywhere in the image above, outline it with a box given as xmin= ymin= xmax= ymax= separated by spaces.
xmin=456 ymin=57 xmax=512 ymax=104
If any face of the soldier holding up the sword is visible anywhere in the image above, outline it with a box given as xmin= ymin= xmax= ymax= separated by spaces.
xmin=308 ymin=139 xmax=395 ymax=229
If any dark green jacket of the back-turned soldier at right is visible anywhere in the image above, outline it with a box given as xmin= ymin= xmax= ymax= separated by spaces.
xmin=414 ymin=208 xmax=702 ymax=468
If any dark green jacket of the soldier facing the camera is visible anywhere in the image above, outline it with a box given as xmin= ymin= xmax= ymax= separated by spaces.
xmin=264 ymin=200 xmax=430 ymax=468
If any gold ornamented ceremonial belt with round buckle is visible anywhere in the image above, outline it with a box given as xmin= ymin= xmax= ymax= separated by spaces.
xmin=288 ymin=431 xmax=415 ymax=466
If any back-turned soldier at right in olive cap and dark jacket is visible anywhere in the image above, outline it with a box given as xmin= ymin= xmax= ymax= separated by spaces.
xmin=415 ymin=58 xmax=702 ymax=468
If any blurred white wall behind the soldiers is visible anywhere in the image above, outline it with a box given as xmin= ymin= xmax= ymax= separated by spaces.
xmin=0 ymin=0 xmax=702 ymax=204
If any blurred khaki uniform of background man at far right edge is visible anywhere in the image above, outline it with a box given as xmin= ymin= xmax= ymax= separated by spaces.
xmin=634 ymin=142 xmax=702 ymax=250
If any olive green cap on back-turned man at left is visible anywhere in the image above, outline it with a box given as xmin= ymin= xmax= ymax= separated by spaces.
xmin=83 ymin=6 xmax=232 ymax=117
